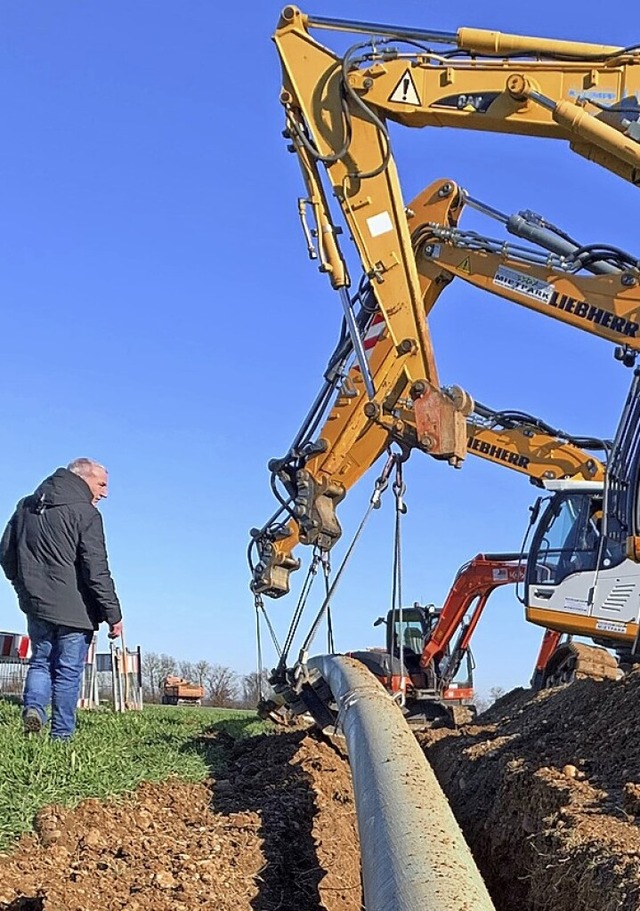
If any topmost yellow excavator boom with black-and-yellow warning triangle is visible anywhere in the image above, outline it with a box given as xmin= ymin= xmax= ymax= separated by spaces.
xmin=275 ymin=6 xmax=640 ymax=184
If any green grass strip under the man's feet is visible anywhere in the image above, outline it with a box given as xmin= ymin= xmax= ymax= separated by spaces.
xmin=0 ymin=703 xmax=269 ymax=849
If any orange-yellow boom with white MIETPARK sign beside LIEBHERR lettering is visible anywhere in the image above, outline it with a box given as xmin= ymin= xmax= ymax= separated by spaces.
xmin=408 ymin=180 xmax=640 ymax=363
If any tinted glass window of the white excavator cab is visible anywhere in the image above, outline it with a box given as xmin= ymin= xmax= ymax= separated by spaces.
xmin=527 ymin=491 xmax=623 ymax=585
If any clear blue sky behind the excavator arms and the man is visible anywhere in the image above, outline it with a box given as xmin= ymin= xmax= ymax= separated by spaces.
xmin=0 ymin=0 xmax=638 ymax=691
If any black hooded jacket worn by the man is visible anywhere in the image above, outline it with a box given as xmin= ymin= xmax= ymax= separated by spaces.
xmin=0 ymin=468 xmax=122 ymax=630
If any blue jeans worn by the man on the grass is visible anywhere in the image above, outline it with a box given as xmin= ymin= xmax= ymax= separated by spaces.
xmin=23 ymin=616 xmax=93 ymax=740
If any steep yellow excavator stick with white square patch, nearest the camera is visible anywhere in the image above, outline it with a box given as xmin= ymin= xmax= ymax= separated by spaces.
xmin=275 ymin=8 xmax=465 ymax=452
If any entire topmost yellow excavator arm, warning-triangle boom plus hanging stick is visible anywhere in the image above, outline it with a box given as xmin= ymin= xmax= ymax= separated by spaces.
xmin=274 ymin=6 xmax=640 ymax=496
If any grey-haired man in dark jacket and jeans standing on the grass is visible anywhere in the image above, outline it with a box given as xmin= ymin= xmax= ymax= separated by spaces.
xmin=0 ymin=459 xmax=122 ymax=740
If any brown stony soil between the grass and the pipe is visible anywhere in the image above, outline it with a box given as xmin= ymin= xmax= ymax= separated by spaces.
xmin=0 ymin=732 xmax=361 ymax=911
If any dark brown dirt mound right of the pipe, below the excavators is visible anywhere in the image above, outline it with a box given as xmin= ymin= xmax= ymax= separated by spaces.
xmin=419 ymin=671 xmax=640 ymax=911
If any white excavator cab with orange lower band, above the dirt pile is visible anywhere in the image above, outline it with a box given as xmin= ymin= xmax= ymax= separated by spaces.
xmin=525 ymin=480 xmax=640 ymax=668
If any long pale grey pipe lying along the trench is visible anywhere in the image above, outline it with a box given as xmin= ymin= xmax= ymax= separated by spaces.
xmin=308 ymin=655 xmax=494 ymax=911
